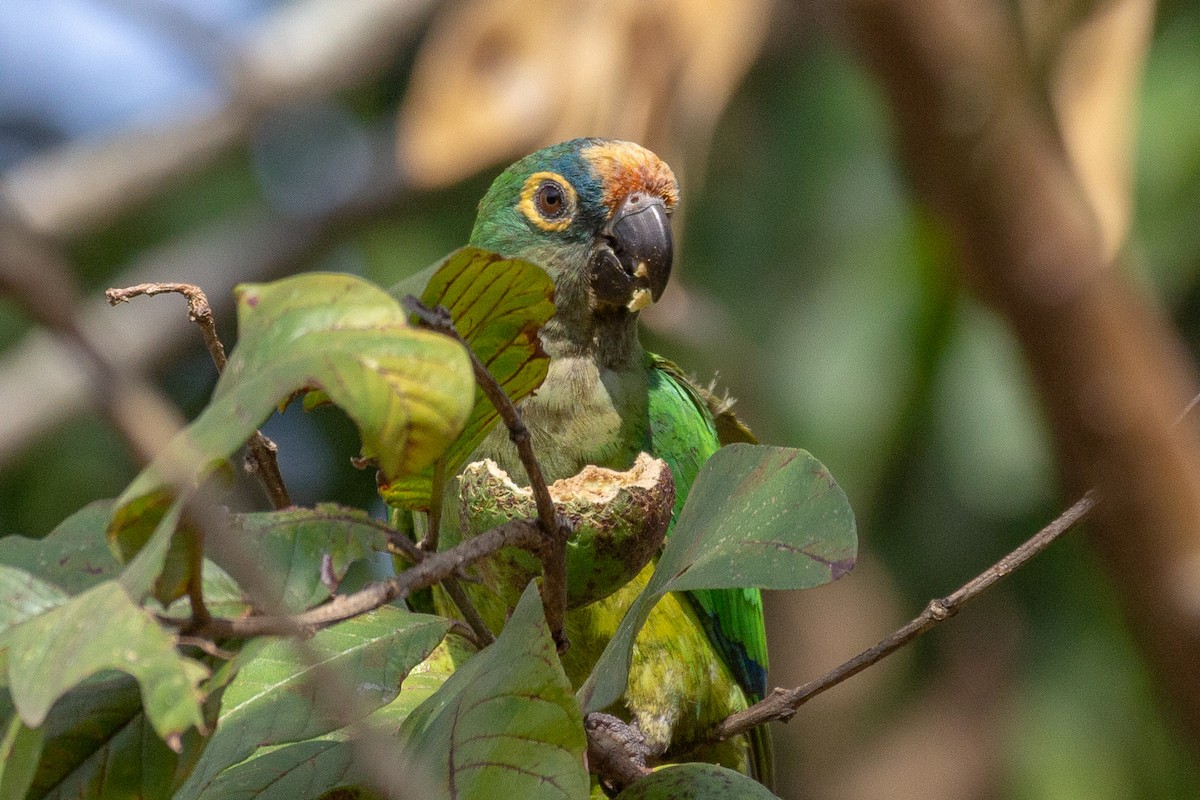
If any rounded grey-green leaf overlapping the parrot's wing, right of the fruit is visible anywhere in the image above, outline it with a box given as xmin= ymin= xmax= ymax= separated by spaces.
xmin=578 ymin=444 xmax=858 ymax=712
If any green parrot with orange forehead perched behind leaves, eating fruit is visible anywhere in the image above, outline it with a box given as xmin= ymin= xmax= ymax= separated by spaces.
xmin=439 ymin=139 xmax=773 ymax=783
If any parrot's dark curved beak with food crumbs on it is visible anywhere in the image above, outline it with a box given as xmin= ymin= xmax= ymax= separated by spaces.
xmin=590 ymin=193 xmax=674 ymax=312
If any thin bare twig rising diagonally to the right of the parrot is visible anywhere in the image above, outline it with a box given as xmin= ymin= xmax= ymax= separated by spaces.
xmin=709 ymin=492 xmax=1097 ymax=741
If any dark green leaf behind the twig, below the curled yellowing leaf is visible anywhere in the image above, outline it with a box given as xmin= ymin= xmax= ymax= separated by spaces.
xmin=213 ymin=503 xmax=388 ymax=613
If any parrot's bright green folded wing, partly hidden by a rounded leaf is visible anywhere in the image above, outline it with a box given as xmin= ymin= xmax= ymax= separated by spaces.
xmin=647 ymin=355 xmax=767 ymax=700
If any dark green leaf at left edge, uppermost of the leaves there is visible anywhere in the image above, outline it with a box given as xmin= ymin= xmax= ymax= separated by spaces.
xmin=0 ymin=500 xmax=121 ymax=595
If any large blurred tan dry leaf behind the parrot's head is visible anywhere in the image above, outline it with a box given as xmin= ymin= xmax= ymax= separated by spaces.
xmin=397 ymin=0 xmax=770 ymax=188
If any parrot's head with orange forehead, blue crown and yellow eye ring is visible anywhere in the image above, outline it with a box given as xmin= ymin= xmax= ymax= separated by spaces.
xmin=470 ymin=139 xmax=679 ymax=331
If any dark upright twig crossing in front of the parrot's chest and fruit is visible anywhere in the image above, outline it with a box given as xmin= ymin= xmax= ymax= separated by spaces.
xmin=403 ymin=295 xmax=571 ymax=654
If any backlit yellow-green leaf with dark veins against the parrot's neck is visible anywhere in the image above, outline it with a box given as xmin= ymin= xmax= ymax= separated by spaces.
xmin=379 ymin=247 xmax=554 ymax=510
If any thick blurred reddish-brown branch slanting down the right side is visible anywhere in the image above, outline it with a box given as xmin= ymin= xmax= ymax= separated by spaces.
xmin=826 ymin=0 xmax=1200 ymax=746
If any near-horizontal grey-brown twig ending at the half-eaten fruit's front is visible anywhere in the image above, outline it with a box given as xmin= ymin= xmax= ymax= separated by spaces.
xmin=178 ymin=521 xmax=545 ymax=639
